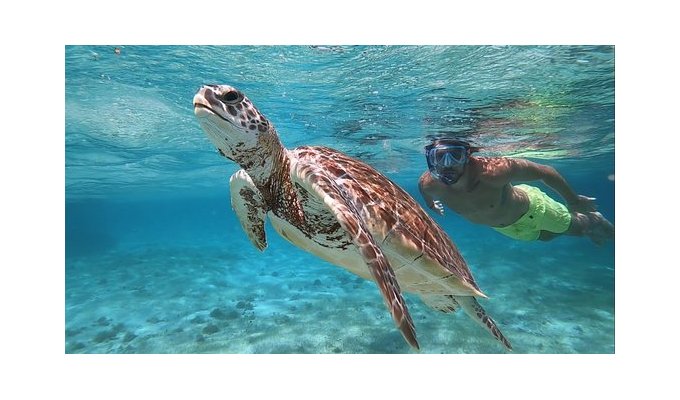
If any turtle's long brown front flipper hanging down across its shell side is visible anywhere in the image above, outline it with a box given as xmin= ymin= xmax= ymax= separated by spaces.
xmin=298 ymin=170 xmax=420 ymax=349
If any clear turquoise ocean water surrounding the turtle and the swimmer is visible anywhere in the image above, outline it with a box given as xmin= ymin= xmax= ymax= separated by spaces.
xmin=65 ymin=46 xmax=616 ymax=354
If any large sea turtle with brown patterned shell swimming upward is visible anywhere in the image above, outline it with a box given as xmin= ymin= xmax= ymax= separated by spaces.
xmin=193 ymin=85 xmax=511 ymax=349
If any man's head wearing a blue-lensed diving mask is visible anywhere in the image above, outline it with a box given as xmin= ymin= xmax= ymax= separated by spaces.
xmin=425 ymin=139 xmax=479 ymax=185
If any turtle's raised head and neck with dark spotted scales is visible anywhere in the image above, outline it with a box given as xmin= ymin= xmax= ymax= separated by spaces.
xmin=194 ymin=85 xmax=279 ymax=168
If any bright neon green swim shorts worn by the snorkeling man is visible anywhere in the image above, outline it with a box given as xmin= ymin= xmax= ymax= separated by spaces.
xmin=493 ymin=185 xmax=571 ymax=240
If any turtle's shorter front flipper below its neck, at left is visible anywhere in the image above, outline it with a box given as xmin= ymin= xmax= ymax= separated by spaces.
xmin=229 ymin=169 xmax=267 ymax=251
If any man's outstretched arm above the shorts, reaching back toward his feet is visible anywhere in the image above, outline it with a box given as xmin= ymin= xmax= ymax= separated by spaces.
xmin=509 ymin=159 xmax=596 ymax=212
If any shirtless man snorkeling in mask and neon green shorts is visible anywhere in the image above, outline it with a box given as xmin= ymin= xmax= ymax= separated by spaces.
xmin=418 ymin=139 xmax=614 ymax=245
